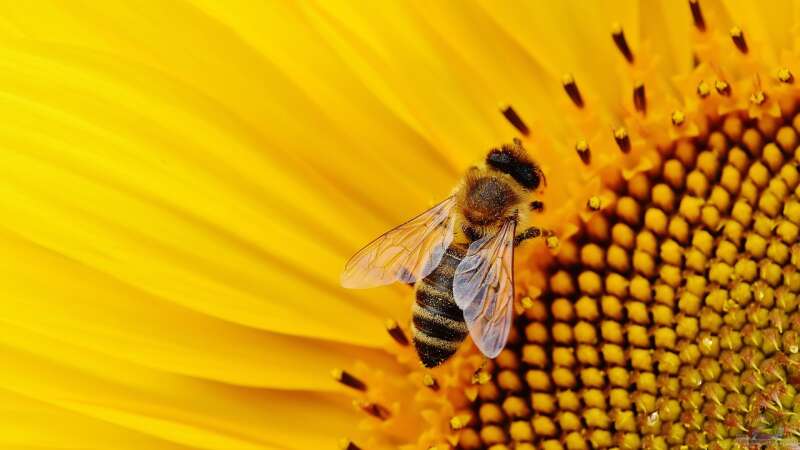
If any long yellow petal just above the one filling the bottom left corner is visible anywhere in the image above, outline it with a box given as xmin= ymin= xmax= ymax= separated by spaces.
xmin=0 ymin=326 xmax=360 ymax=449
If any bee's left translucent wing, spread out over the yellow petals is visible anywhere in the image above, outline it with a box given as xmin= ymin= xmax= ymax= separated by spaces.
xmin=342 ymin=197 xmax=456 ymax=288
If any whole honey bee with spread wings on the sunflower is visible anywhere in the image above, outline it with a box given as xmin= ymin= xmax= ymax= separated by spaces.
xmin=342 ymin=140 xmax=546 ymax=368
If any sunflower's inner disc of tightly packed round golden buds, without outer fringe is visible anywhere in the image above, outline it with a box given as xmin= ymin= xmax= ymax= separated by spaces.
xmin=459 ymin=115 xmax=800 ymax=450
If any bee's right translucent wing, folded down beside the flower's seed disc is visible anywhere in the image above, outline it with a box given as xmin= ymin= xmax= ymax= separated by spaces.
xmin=453 ymin=220 xmax=516 ymax=358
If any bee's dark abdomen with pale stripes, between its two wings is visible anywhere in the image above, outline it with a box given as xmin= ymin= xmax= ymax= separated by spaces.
xmin=411 ymin=244 xmax=468 ymax=367
